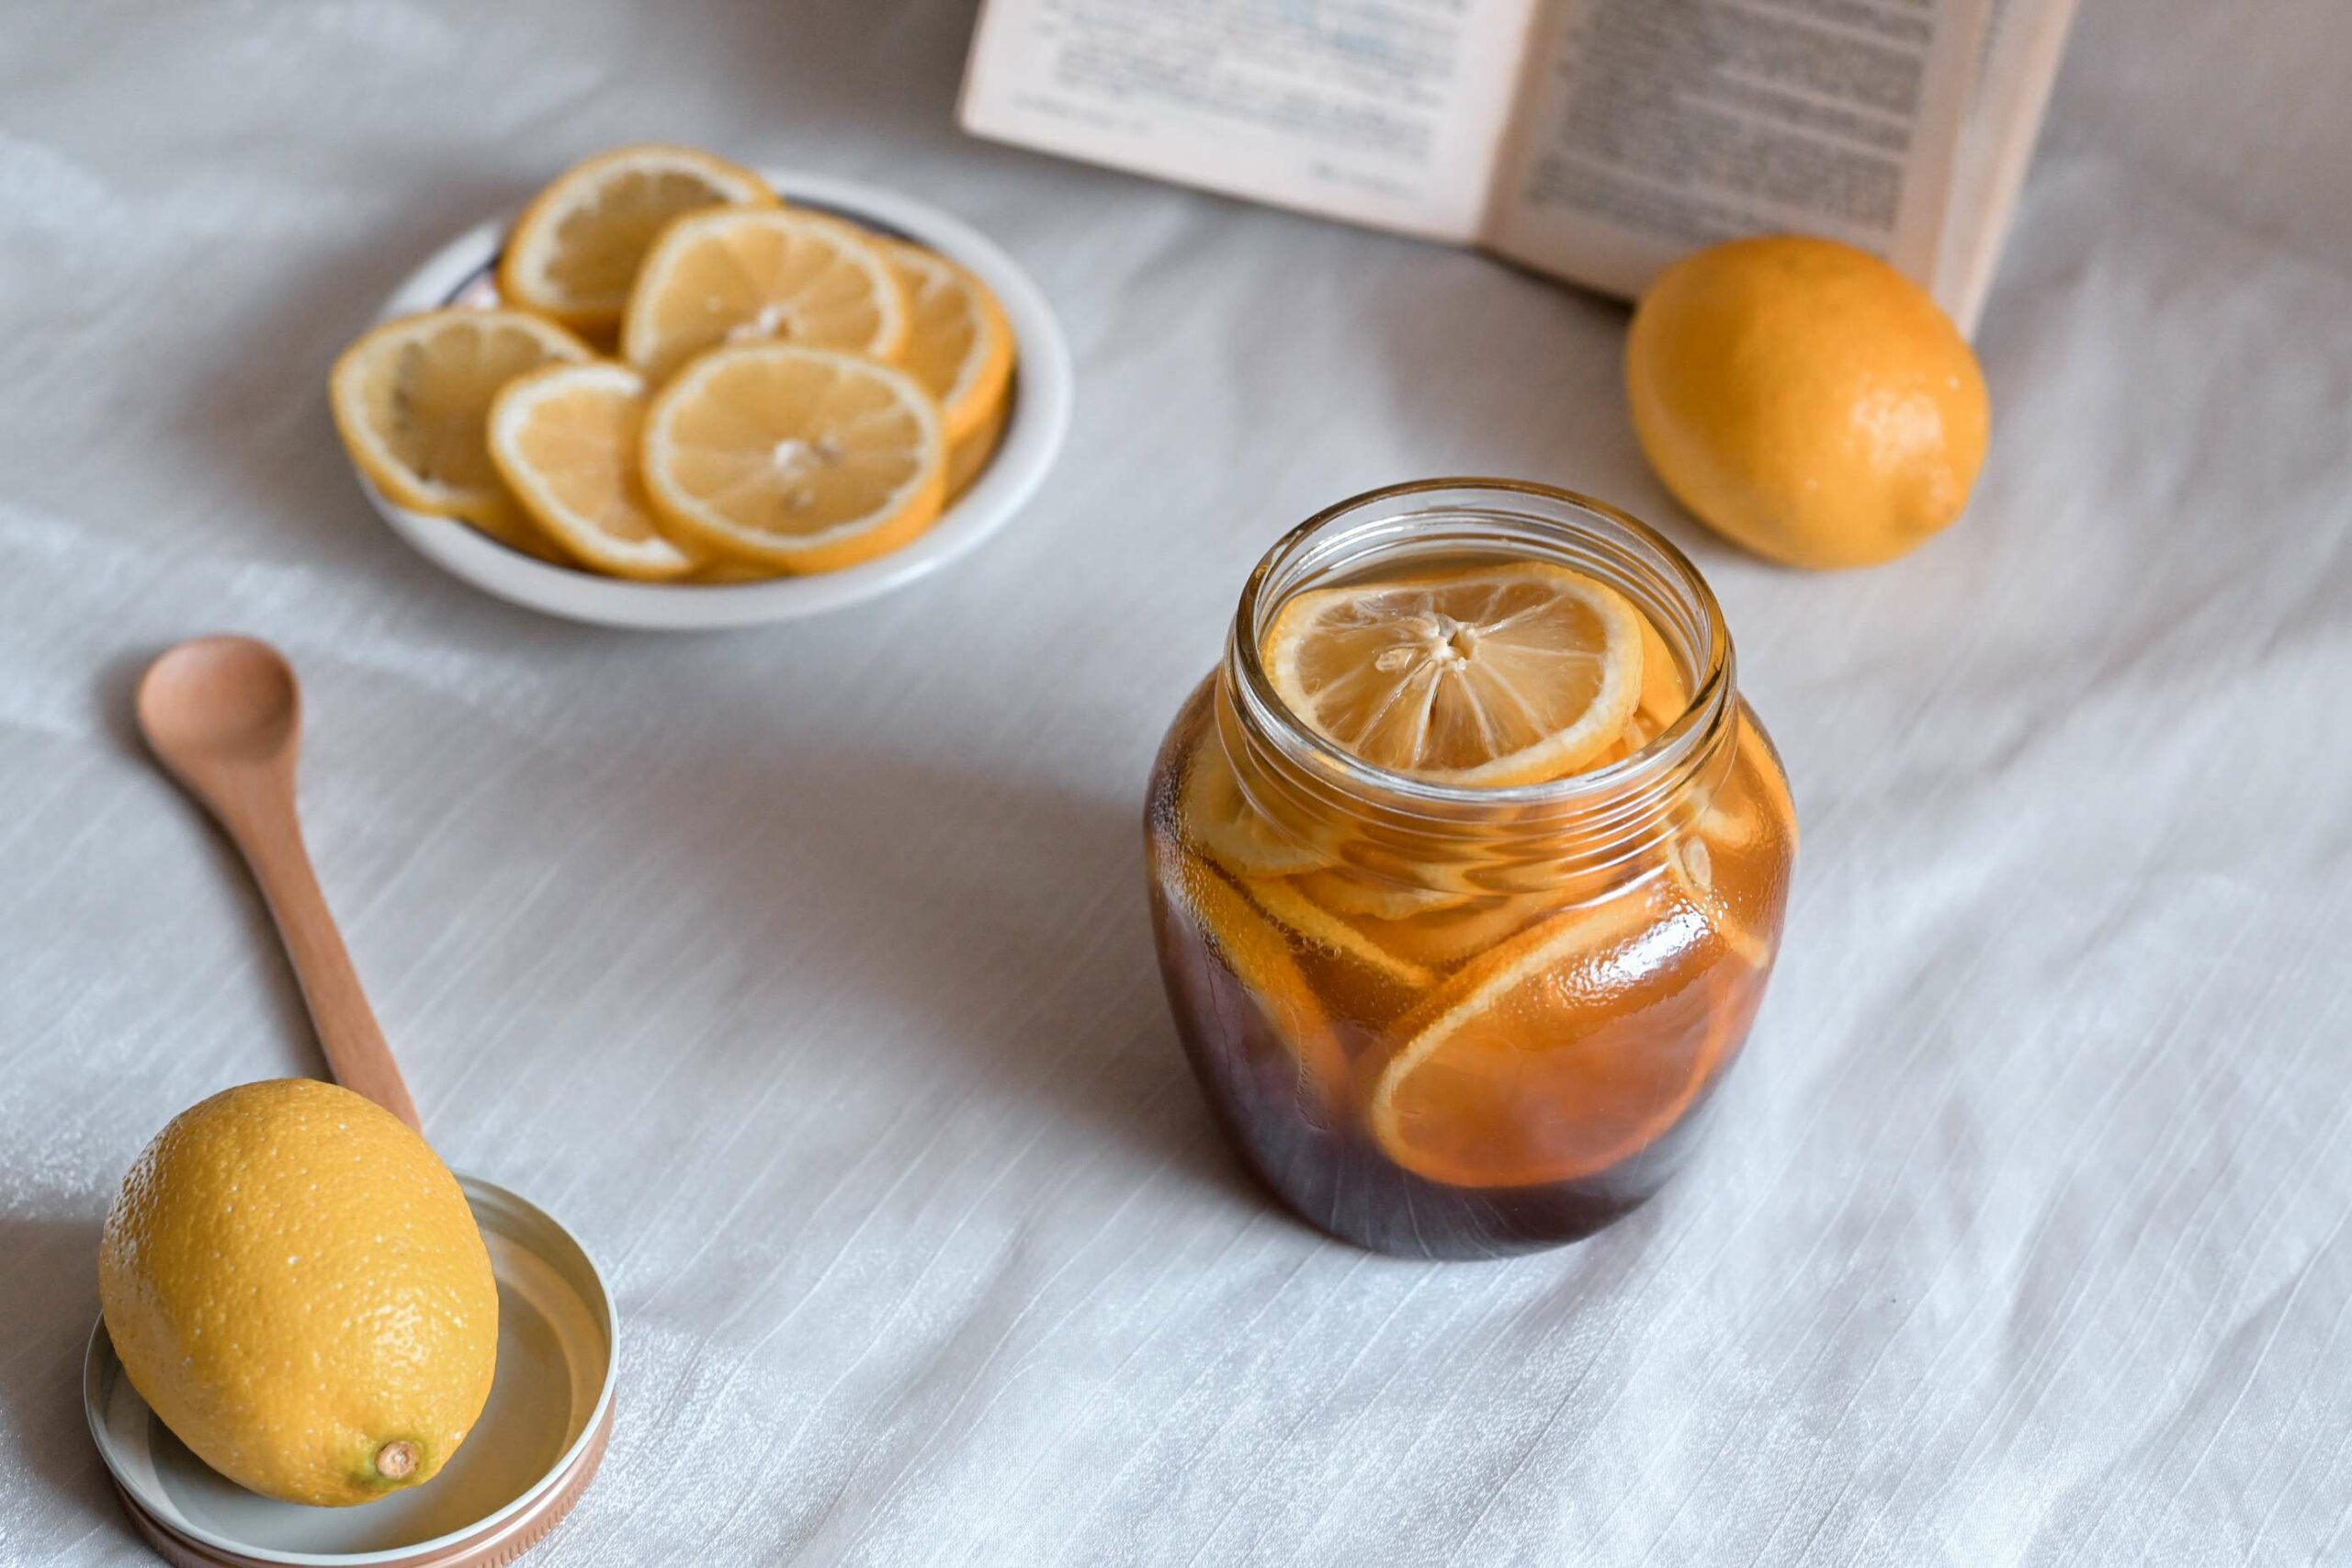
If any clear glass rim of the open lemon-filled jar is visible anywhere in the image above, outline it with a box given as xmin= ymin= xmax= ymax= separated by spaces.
xmin=1226 ymin=478 xmax=1736 ymax=811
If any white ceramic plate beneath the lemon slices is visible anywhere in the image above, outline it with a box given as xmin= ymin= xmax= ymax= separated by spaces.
xmin=356 ymin=169 xmax=1070 ymax=630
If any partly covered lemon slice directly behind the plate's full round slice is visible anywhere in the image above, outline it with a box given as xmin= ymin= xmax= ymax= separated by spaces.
xmin=621 ymin=207 xmax=910 ymax=383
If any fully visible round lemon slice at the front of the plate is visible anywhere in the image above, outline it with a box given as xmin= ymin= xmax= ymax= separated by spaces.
xmin=644 ymin=344 xmax=948 ymax=571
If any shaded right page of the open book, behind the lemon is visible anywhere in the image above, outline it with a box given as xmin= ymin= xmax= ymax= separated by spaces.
xmin=1487 ymin=0 xmax=1987 ymax=308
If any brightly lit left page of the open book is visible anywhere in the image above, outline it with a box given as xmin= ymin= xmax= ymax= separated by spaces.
xmin=962 ymin=0 xmax=1536 ymax=243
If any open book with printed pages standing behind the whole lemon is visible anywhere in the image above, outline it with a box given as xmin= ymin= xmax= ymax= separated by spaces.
xmin=962 ymin=0 xmax=2075 ymax=332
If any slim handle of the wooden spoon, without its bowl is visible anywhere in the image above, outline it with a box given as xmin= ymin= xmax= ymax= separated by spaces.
xmin=221 ymin=781 xmax=424 ymax=1134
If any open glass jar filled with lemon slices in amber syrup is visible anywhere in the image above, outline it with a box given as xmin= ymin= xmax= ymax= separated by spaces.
xmin=1146 ymin=479 xmax=1797 ymax=1258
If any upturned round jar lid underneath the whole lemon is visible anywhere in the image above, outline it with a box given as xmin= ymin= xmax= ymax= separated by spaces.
xmin=83 ymin=1176 xmax=618 ymax=1568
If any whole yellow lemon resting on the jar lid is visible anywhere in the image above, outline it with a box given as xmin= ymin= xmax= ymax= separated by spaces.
xmin=99 ymin=1079 xmax=499 ymax=1506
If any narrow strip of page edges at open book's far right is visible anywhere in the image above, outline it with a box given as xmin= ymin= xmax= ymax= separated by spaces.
xmin=1936 ymin=0 xmax=2075 ymax=336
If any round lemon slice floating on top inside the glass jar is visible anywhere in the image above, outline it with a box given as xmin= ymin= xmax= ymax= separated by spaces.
xmin=1263 ymin=562 xmax=1642 ymax=790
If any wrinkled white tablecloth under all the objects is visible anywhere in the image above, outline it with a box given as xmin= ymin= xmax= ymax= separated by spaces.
xmin=0 ymin=0 xmax=2352 ymax=1568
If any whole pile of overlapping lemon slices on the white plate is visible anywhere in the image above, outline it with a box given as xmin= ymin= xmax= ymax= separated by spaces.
xmin=329 ymin=146 xmax=1013 ymax=583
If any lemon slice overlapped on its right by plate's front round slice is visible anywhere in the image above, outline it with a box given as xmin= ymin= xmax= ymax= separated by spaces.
xmin=489 ymin=360 xmax=701 ymax=583
